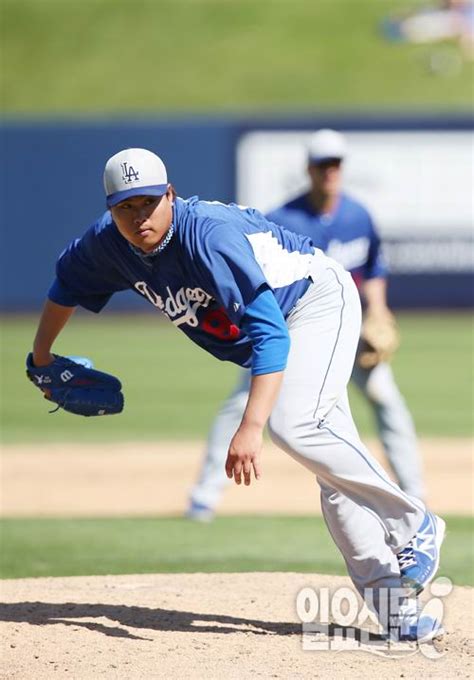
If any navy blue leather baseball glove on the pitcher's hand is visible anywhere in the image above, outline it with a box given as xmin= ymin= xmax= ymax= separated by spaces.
xmin=26 ymin=353 xmax=123 ymax=416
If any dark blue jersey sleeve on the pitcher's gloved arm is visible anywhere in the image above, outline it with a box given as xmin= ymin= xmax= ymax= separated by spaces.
xmin=48 ymin=229 xmax=128 ymax=313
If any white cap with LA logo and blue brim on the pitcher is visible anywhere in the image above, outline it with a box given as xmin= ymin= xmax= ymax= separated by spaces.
xmin=104 ymin=149 xmax=168 ymax=208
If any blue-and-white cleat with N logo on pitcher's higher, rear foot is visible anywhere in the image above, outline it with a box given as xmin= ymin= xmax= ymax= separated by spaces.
xmin=397 ymin=512 xmax=446 ymax=595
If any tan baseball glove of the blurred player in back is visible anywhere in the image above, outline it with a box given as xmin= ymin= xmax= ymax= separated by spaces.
xmin=356 ymin=310 xmax=400 ymax=368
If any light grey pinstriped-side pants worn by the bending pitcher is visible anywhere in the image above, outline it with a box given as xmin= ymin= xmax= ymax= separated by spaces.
xmin=191 ymin=258 xmax=425 ymax=590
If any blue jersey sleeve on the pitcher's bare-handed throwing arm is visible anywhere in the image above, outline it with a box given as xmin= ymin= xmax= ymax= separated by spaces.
xmin=195 ymin=223 xmax=268 ymax=325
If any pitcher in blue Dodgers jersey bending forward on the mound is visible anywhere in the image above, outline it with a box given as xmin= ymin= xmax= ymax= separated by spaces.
xmin=27 ymin=149 xmax=444 ymax=638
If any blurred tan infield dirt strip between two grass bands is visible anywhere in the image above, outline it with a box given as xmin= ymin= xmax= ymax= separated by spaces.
xmin=1 ymin=439 xmax=474 ymax=517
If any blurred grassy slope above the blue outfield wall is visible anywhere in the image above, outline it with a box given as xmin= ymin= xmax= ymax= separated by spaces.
xmin=0 ymin=0 xmax=473 ymax=115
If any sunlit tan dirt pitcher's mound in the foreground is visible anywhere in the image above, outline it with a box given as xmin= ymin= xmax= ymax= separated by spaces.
xmin=0 ymin=573 xmax=474 ymax=680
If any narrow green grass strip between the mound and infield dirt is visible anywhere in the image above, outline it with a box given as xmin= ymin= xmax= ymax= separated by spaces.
xmin=0 ymin=516 xmax=474 ymax=585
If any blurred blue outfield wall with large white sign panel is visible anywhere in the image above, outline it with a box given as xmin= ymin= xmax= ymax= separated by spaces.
xmin=0 ymin=116 xmax=474 ymax=311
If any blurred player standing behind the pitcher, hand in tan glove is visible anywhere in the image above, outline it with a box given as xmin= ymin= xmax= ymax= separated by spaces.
xmin=186 ymin=130 xmax=425 ymax=521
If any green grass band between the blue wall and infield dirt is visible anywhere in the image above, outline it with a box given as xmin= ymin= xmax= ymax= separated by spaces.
xmin=0 ymin=313 xmax=473 ymax=443
